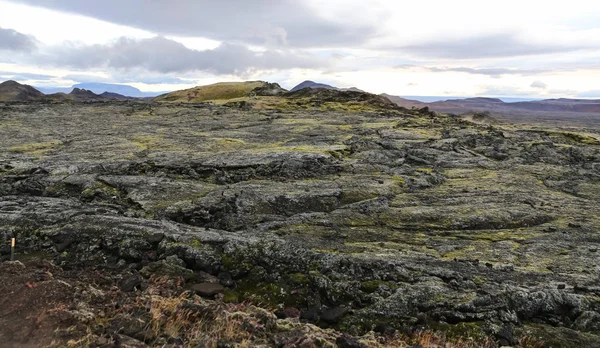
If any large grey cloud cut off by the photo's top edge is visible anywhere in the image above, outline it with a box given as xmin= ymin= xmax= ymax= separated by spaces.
xmin=12 ymin=0 xmax=377 ymax=47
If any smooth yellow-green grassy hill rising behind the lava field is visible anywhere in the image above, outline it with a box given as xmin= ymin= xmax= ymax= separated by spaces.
xmin=154 ymin=81 xmax=266 ymax=103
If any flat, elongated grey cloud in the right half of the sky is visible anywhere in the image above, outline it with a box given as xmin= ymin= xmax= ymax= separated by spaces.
xmin=388 ymin=33 xmax=592 ymax=59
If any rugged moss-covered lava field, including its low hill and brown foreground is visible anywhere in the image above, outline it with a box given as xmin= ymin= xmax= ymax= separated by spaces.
xmin=0 ymin=81 xmax=600 ymax=347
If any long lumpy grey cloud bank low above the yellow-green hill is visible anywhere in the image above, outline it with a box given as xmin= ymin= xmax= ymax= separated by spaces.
xmin=34 ymin=37 xmax=324 ymax=75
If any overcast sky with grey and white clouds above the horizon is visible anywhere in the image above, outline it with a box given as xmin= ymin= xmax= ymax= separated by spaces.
xmin=0 ymin=0 xmax=600 ymax=99
